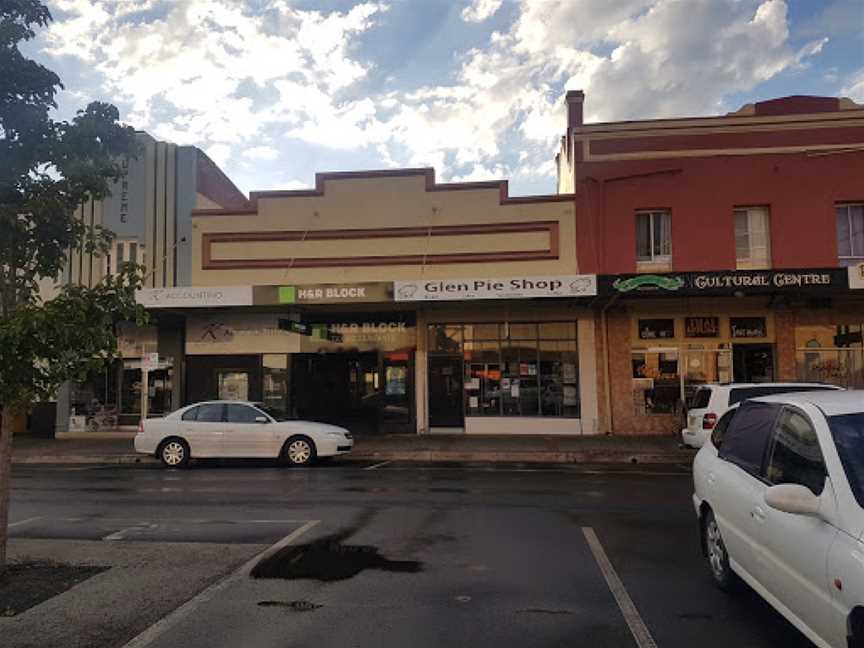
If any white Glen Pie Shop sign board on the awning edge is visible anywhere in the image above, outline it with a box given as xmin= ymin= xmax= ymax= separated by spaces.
xmin=393 ymin=275 xmax=597 ymax=301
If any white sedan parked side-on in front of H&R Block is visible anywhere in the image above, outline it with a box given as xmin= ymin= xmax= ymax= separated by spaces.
xmin=135 ymin=401 xmax=354 ymax=468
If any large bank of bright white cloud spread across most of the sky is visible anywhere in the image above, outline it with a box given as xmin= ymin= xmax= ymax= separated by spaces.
xmin=42 ymin=0 xmax=832 ymax=188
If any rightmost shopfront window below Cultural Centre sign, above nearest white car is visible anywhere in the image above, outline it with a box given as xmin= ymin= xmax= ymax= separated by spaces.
xmin=795 ymin=324 xmax=864 ymax=389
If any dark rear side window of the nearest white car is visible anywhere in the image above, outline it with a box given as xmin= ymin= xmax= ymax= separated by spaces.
xmin=719 ymin=403 xmax=782 ymax=477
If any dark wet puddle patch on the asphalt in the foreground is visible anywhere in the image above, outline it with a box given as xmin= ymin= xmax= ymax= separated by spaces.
xmin=251 ymin=529 xmax=423 ymax=582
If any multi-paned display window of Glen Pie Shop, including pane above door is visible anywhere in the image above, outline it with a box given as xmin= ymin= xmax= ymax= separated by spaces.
xmin=428 ymin=322 xmax=580 ymax=418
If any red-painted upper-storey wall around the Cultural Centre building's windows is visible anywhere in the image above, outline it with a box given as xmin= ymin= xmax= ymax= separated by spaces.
xmin=575 ymin=150 xmax=864 ymax=274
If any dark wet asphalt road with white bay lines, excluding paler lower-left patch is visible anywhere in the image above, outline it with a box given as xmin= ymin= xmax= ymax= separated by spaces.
xmin=11 ymin=463 xmax=810 ymax=648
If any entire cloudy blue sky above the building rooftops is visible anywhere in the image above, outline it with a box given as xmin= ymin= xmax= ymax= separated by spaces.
xmin=25 ymin=0 xmax=864 ymax=195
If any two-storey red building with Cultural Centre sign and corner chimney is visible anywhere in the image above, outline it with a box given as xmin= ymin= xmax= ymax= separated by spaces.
xmin=556 ymin=92 xmax=864 ymax=433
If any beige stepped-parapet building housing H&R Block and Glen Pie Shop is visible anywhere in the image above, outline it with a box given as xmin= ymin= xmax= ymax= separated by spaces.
xmin=172 ymin=169 xmax=601 ymax=434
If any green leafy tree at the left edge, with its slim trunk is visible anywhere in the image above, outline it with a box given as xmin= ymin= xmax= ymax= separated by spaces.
xmin=0 ymin=0 xmax=144 ymax=570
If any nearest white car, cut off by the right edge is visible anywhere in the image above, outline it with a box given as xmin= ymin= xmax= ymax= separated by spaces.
xmin=693 ymin=391 xmax=864 ymax=648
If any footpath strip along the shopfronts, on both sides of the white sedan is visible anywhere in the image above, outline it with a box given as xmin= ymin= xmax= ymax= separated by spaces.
xmin=12 ymin=434 xmax=694 ymax=465
